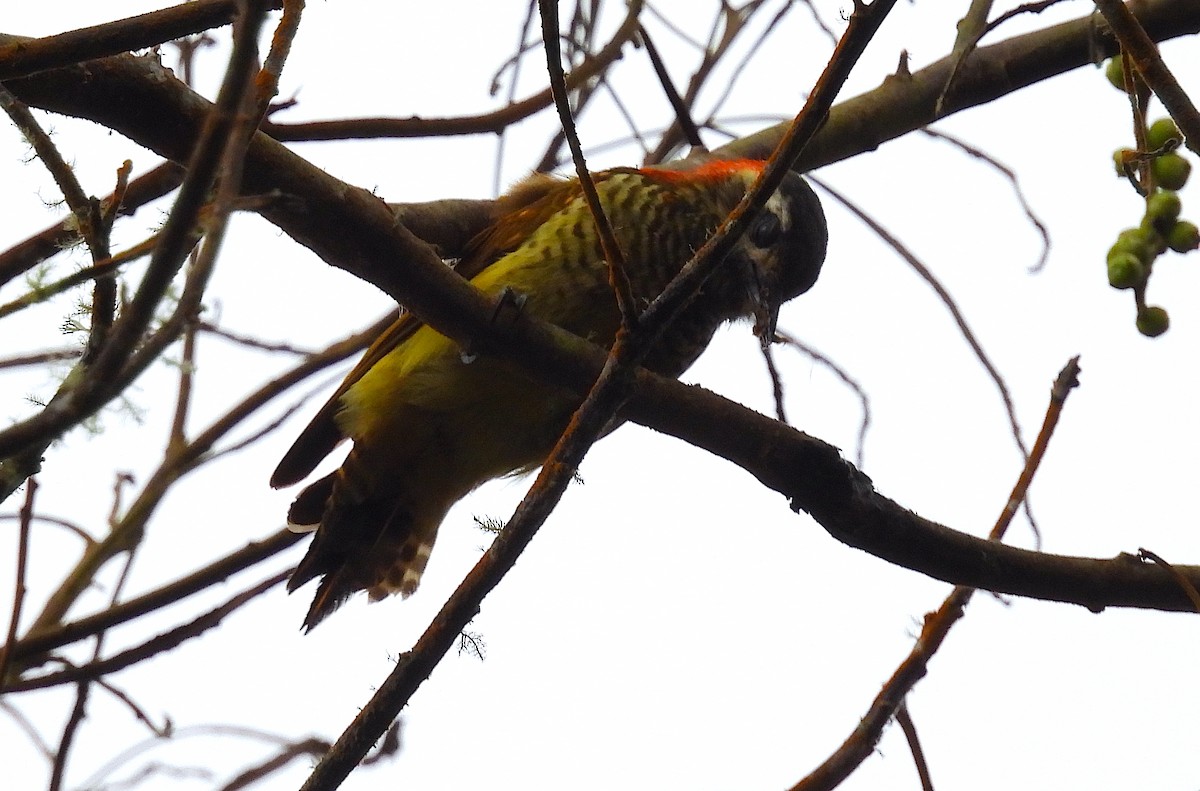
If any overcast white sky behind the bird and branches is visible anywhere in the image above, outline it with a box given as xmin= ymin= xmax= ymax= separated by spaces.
xmin=0 ymin=0 xmax=1200 ymax=791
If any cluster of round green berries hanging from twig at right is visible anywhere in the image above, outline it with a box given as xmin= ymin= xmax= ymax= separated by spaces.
xmin=1105 ymin=55 xmax=1200 ymax=337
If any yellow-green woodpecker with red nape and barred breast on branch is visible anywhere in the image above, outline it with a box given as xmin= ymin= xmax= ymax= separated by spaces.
xmin=271 ymin=160 xmax=828 ymax=629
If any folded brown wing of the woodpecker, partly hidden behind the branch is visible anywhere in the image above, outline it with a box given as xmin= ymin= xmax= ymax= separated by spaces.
xmin=271 ymin=175 xmax=578 ymax=489
